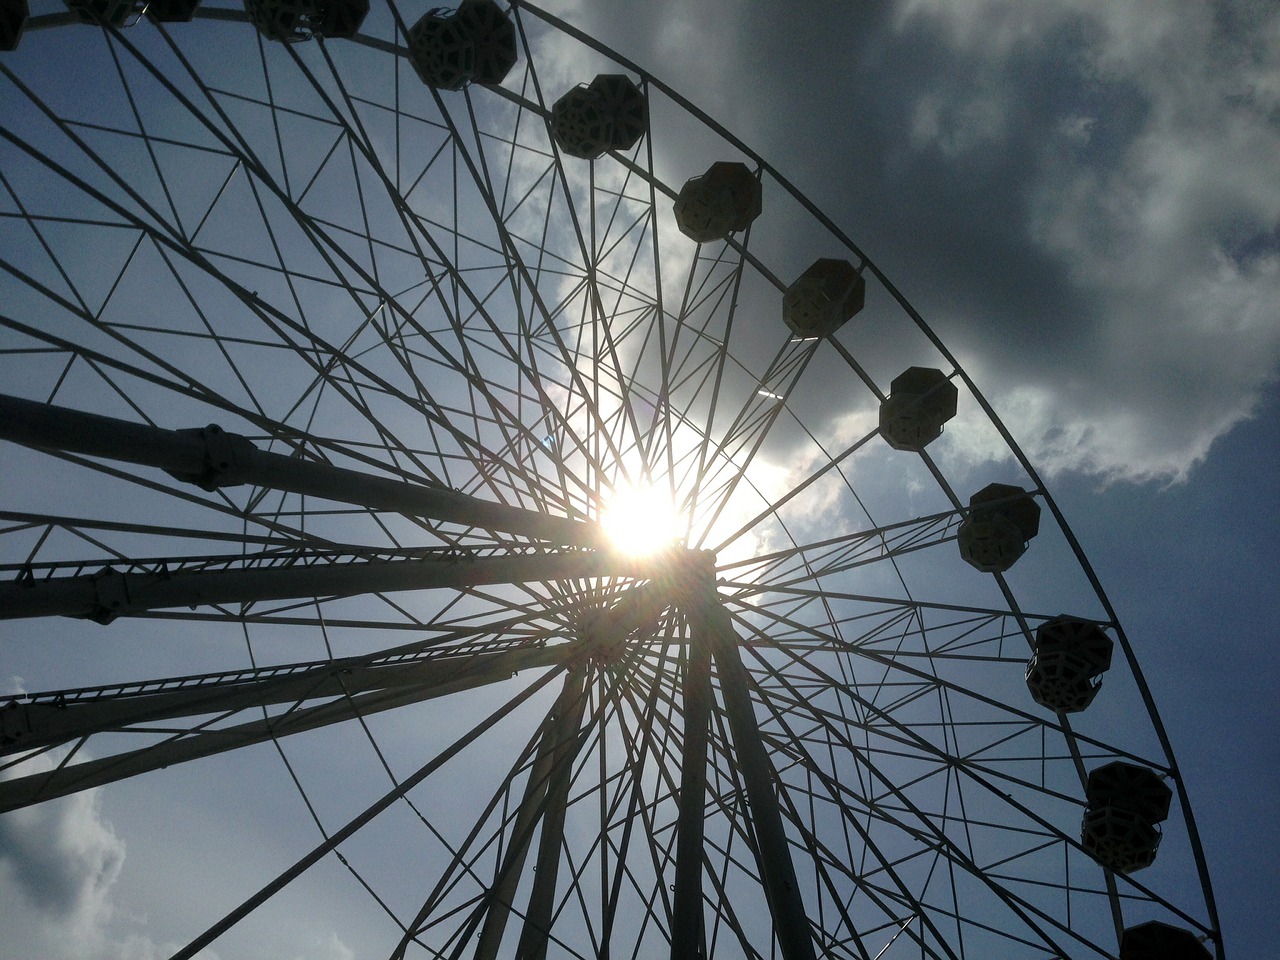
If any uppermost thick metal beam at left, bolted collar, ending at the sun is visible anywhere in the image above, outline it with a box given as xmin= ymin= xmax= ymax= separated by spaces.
xmin=0 ymin=394 xmax=604 ymax=547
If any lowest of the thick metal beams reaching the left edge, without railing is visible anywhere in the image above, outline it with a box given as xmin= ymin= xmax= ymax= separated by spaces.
xmin=0 ymin=643 xmax=570 ymax=813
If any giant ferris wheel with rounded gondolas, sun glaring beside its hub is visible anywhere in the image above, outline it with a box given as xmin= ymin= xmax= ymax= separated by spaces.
xmin=0 ymin=0 xmax=1224 ymax=960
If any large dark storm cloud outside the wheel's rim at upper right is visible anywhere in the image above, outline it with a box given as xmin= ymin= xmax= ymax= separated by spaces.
xmin=555 ymin=0 xmax=1280 ymax=480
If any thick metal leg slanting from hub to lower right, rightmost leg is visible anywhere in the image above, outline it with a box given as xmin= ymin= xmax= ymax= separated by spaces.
xmin=684 ymin=571 xmax=815 ymax=960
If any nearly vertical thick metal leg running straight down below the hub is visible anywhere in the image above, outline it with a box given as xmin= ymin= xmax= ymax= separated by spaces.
xmin=671 ymin=635 xmax=712 ymax=960
